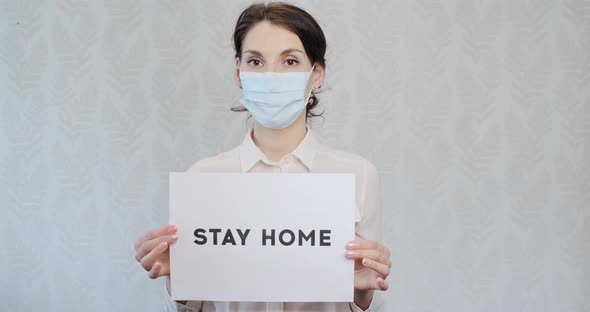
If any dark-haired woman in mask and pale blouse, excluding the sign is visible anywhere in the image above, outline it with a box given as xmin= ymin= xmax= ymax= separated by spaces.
xmin=135 ymin=3 xmax=391 ymax=312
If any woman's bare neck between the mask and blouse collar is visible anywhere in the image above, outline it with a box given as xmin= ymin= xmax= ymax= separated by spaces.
xmin=252 ymin=112 xmax=307 ymax=161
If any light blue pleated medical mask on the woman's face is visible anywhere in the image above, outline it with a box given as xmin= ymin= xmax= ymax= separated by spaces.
xmin=240 ymin=65 xmax=315 ymax=129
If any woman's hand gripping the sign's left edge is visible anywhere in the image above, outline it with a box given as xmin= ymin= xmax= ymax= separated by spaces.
xmin=135 ymin=225 xmax=178 ymax=279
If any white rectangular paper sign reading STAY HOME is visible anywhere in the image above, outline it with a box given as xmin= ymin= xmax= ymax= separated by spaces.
xmin=170 ymin=172 xmax=355 ymax=302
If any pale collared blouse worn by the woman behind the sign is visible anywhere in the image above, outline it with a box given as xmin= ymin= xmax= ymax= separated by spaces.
xmin=166 ymin=128 xmax=381 ymax=312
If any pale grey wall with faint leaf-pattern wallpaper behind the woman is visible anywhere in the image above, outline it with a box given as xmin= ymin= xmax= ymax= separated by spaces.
xmin=0 ymin=0 xmax=590 ymax=312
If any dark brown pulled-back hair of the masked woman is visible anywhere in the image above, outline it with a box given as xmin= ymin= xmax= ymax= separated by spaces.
xmin=232 ymin=2 xmax=326 ymax=118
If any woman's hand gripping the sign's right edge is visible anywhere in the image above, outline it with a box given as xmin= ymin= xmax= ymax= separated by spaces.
xmin=346 ymin=239 xmax=391 ymax=291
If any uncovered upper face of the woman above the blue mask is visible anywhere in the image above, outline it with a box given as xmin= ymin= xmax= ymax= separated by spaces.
xmin=234 ymin=21 xmax=324 ymax=94
